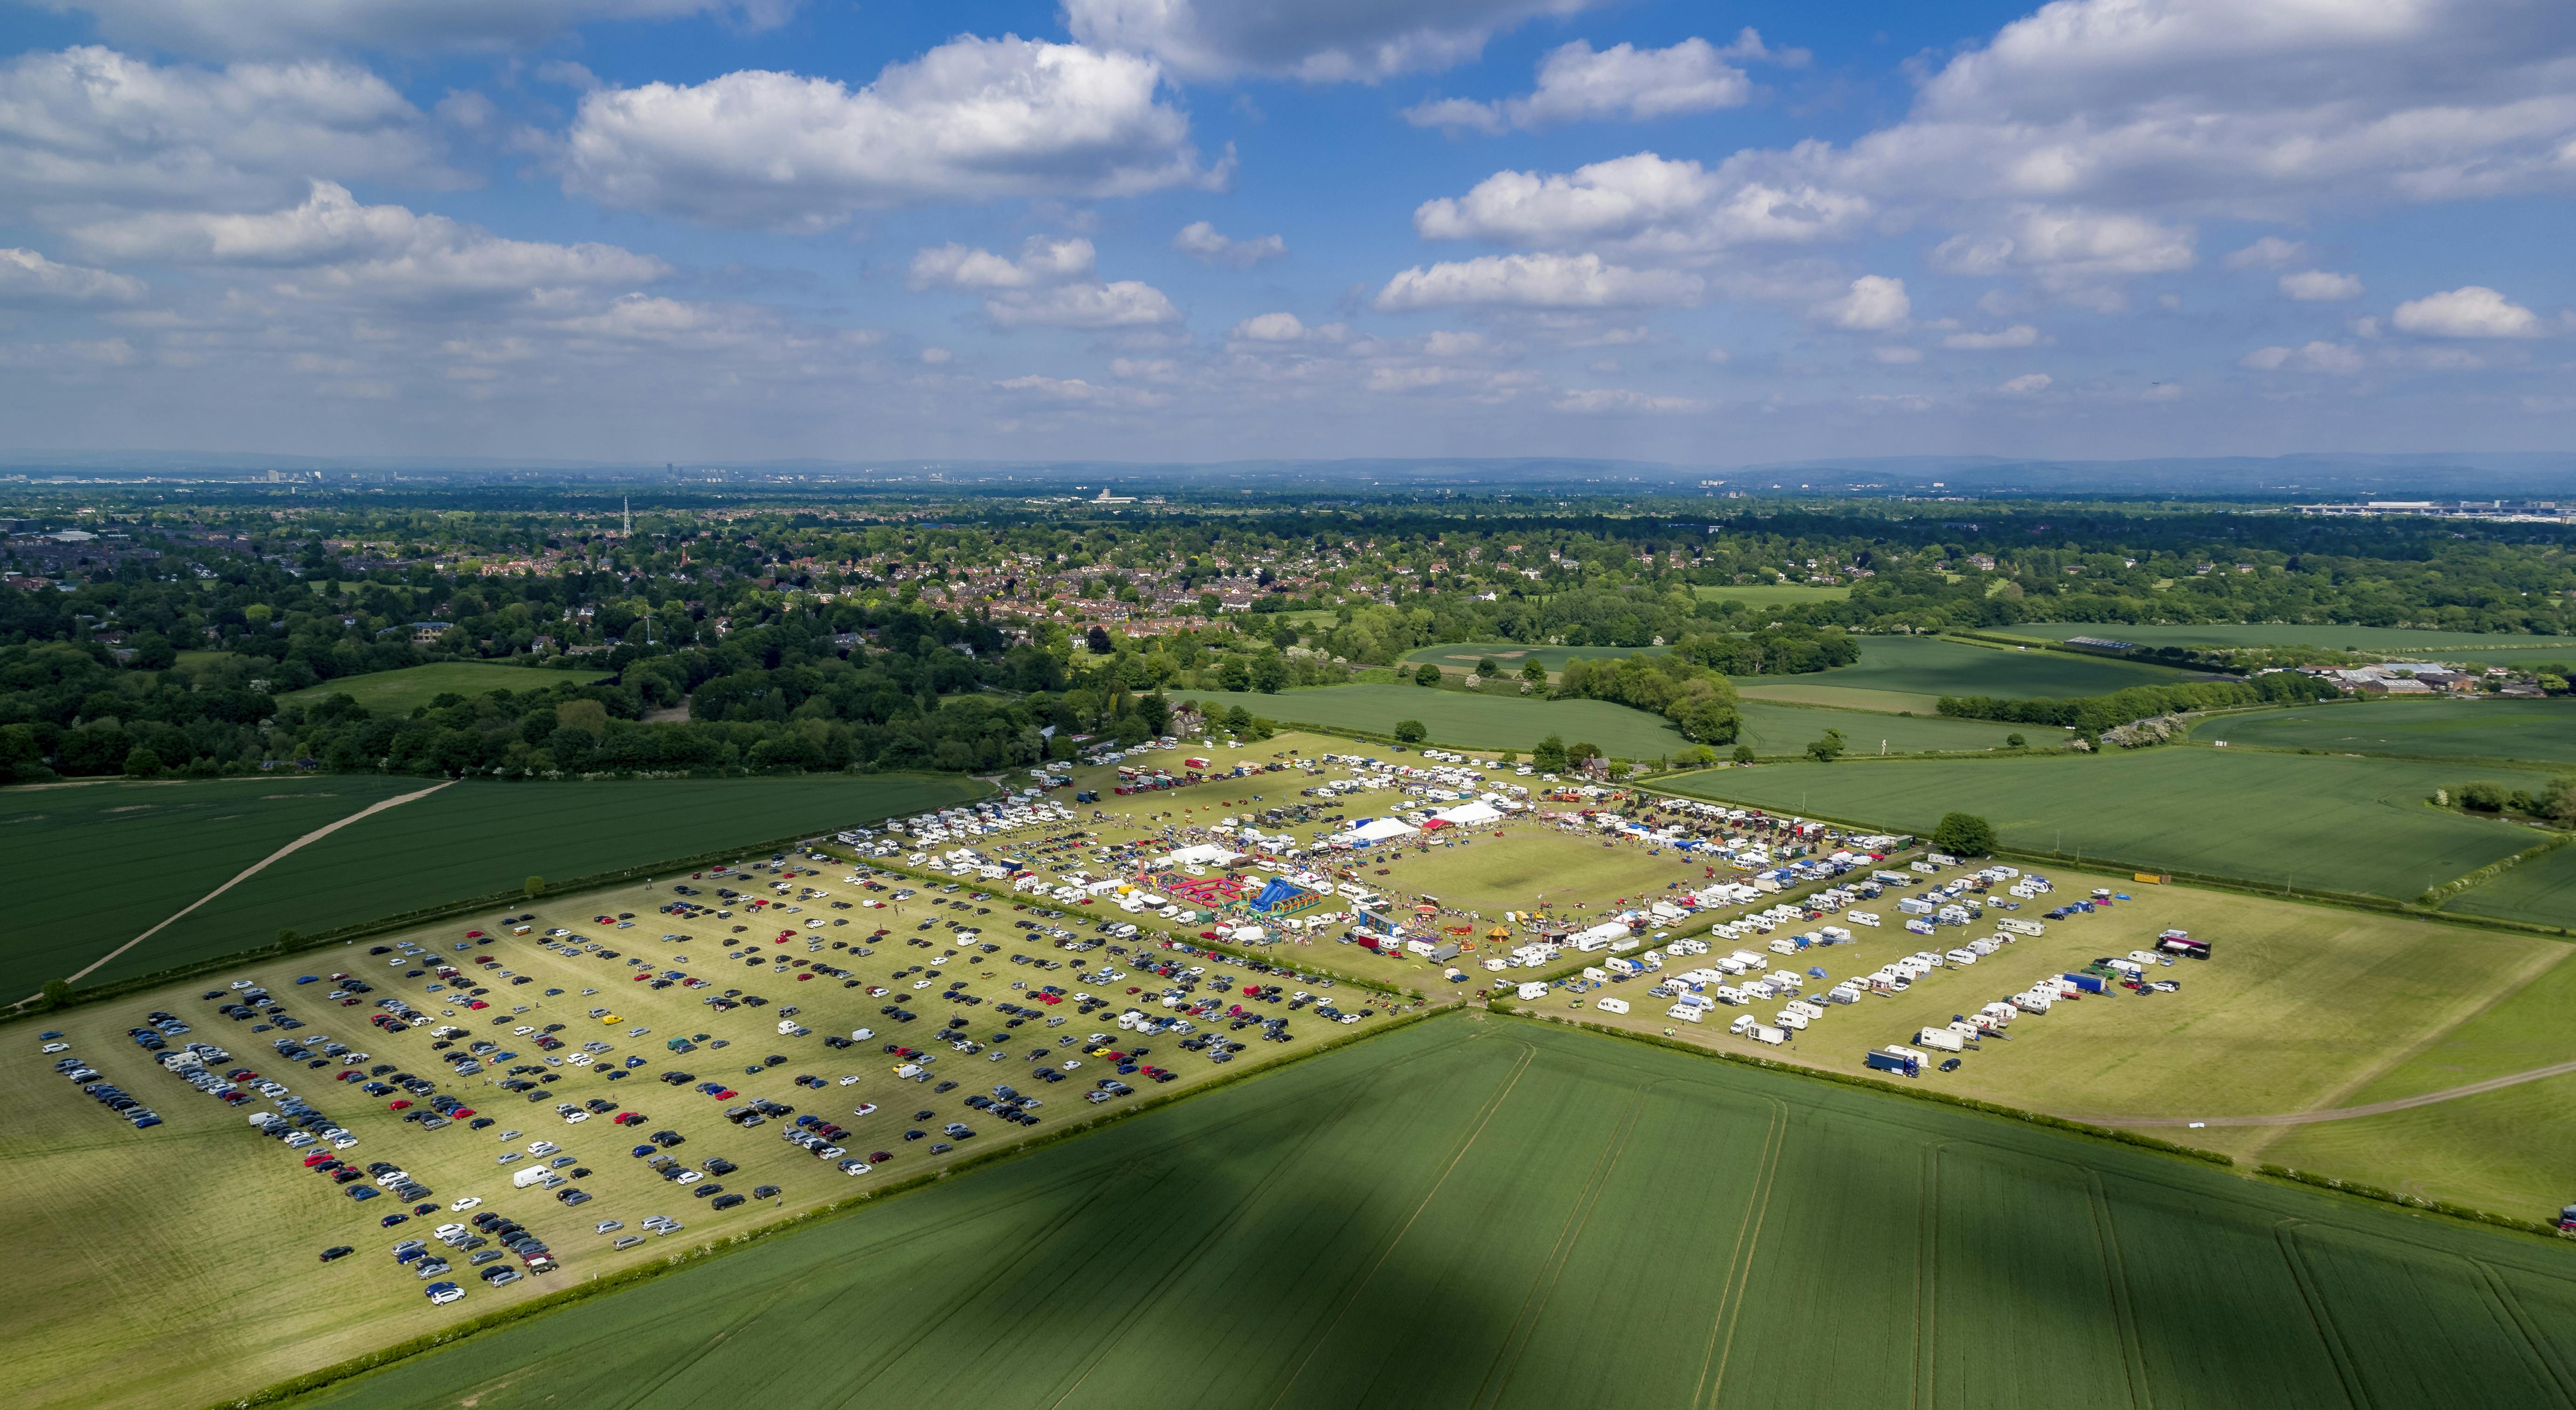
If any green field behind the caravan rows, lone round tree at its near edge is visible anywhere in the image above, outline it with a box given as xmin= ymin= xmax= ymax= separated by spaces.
xmin=1669 ymin=747 xmax=2542 ymax=897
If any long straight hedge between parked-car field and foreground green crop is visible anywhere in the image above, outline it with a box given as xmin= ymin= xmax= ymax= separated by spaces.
xmin=209 ymin=1008 xmax=1445 ymax=1410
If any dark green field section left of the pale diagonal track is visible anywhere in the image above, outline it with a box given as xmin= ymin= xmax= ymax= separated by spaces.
xmin=0 ymin=776 xmax=428 ymax=1003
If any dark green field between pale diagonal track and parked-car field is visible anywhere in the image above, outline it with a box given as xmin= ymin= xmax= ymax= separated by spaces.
xmin=82 ymin=773 xmax=984 ymax=982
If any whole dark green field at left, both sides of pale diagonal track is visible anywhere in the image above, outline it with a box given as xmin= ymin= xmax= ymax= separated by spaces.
xmin=15 ymin=773 xmax=984 ymax=997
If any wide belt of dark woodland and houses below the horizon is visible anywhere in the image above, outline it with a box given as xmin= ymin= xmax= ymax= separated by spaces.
xmin=0 ymin=500 xmax=2576 ymax=779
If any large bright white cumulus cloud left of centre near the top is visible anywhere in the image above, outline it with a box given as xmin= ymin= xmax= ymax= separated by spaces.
xmin=559 ymin=36 xmax=1211 ymax=230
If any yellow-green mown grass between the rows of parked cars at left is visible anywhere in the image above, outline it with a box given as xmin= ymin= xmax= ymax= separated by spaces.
xmin=0 ymin=866 xmax=1368 ymax=1410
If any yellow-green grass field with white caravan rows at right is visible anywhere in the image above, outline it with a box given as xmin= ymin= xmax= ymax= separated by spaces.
xmin=1543 ymin=866 xmax=2576 ymax=1149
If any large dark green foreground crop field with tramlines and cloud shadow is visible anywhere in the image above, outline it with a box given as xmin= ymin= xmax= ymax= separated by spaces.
xmin=256 ymin=1016 xmax=2576 ymax=1410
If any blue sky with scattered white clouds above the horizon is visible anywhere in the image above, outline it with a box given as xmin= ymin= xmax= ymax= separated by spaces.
xmin=0 ymin=0 xmax=2576 ymax=464
